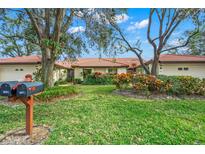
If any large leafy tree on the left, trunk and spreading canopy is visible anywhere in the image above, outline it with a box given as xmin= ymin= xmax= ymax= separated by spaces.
xmin=0 ymin=8 xmax=123 ymax=87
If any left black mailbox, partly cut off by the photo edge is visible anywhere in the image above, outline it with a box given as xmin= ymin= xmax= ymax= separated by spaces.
xmin=0 ymin=81 xmax=18 ymax=96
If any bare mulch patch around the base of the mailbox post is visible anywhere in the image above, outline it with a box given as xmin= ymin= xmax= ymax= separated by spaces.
xmin=0 ymin=126 xmax=50 ymax=145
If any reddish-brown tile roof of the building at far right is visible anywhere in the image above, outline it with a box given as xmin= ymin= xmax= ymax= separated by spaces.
xmin=159 ymin=54 xmax=205 ymax=62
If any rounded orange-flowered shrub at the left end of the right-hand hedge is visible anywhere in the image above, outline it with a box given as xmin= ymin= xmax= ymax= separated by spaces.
xmin=114 ymin=73 xmax=133 ymax=89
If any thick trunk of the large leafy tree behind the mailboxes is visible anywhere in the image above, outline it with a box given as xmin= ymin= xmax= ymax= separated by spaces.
xmin=42 ymin=48 xmax=55 ymax=87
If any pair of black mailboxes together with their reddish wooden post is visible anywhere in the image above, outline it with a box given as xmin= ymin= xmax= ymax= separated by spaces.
xmin=0 ymin=81 xmax=44 ymax=135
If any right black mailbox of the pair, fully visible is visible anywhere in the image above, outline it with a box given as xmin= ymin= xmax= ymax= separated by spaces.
xmin=16 ymin=82 xmax=44 ymax=97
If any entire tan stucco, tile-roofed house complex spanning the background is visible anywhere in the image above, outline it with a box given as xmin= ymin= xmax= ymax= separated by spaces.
xmin=0 ymin=54 xmax=205 ymax=82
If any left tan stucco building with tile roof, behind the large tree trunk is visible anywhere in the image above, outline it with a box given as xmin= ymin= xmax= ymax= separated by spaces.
xmin=0 ymin=56 xmax=68 ymax=82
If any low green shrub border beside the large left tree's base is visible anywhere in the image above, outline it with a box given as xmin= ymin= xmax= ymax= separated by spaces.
xmin=35 ymin=86 xmax=77 ymax=101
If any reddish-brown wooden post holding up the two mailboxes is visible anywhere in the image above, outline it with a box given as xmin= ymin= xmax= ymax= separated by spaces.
xmin=25 ymin=96 xmax=33 ymax=135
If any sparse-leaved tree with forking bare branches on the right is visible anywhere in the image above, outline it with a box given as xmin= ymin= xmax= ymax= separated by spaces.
xmin=109 ymin=8 xmax=200 ymax=75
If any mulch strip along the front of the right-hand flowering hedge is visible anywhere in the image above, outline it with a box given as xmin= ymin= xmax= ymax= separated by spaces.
xmin=113 ymin=89 xmax=205 ymax=100
